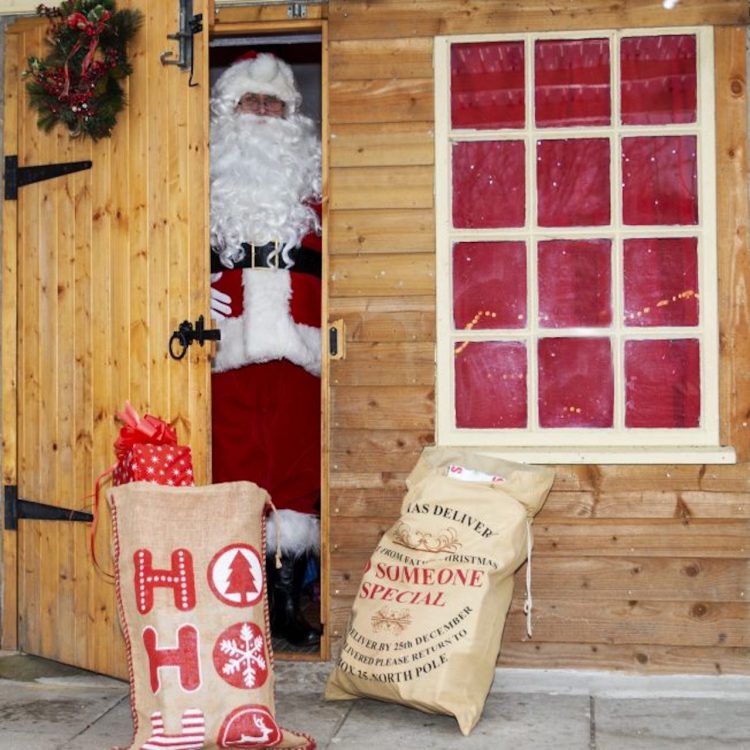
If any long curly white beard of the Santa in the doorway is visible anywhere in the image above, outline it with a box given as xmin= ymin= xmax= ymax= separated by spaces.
xmin=210 ymin=113 xmax=321 ymax=268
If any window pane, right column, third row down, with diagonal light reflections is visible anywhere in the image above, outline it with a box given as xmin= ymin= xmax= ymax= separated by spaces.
xmin=624 ymin=237 xmax=699 ymax=326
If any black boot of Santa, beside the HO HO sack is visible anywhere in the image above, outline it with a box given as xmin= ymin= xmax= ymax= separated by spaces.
xmin=266 ymin=555 xmax=320 ymax=648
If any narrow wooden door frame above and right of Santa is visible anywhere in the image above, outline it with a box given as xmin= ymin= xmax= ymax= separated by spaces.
xmin=209 ymin=8 xmax=331 ymax=661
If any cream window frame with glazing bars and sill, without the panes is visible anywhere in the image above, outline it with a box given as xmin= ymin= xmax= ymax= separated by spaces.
xmin=434 ymin=26 xmax=735 ymax=463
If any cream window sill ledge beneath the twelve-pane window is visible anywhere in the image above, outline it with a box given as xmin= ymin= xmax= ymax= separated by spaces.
xmin=468 ymin=446 xmax=737 ymax=464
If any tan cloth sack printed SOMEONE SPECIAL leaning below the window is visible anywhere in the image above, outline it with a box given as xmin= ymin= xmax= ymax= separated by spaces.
xmin=325 ymin=448 xmax=554 ymax=734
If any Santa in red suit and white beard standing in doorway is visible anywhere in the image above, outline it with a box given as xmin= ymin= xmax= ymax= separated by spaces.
xmin=210 ymin=53 xmax=321 ymax=646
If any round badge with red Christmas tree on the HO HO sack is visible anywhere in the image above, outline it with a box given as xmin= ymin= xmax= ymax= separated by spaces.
xmin=208 ymin=542 xmax=263 ymax=607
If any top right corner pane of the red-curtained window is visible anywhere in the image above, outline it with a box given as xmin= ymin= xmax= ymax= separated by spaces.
xmin=620 ymin=34 xmax=697 ymax=125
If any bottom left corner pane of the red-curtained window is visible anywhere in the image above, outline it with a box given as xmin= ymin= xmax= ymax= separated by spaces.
xmin=455 ymin=341 xmax=527 ymax=429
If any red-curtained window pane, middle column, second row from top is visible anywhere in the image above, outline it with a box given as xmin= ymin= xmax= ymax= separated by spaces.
xmin=536 ymin=138 xmax=610 ymax=227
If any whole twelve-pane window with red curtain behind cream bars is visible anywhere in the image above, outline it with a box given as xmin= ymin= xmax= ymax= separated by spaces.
xmin=435 ymin=28 xmax=719 ymax=458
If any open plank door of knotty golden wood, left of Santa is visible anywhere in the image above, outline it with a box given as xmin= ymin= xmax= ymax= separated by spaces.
xmin=2 ymin=0 xmax=210 ymax=677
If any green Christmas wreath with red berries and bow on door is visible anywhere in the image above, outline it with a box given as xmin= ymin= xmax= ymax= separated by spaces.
xmin=24 ymin=0 xmax=143 ymax=141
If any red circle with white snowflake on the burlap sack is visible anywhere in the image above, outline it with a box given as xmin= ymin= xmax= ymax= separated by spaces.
xmin=213 ymin=622 xmax=268 ymax=688
